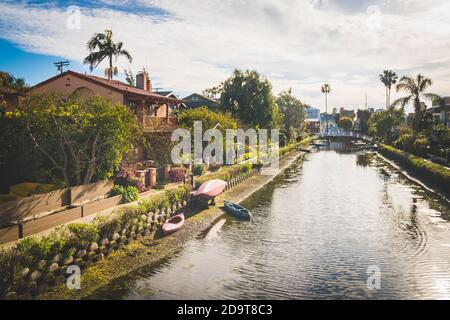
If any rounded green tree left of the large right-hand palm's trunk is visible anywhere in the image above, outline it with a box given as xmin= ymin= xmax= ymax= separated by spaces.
xmin=368 ymin=108 xmax=405 ymax=142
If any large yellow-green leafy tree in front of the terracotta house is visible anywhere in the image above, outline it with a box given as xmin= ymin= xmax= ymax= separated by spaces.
xmin=10 ymin=94 xmax=139 ymax=186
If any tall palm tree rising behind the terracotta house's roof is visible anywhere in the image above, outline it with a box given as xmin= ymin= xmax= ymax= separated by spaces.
xmin=83 ymin=30 xmax=133 ymax=80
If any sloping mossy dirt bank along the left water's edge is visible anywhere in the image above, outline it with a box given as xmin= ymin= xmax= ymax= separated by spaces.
xmin=37 ymin=151 xmax=305 ymax=300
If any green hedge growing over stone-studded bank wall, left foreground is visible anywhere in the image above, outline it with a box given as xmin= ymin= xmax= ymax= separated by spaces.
xmin=0 ymin=185 xmax=192 ymax=299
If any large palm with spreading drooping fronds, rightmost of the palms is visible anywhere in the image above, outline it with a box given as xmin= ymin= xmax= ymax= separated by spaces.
xmin=392 ymin=74 xmax=442 ymax=132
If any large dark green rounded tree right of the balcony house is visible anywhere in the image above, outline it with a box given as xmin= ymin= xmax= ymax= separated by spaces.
xmin=205 ymin=70 xmax=281 ymax=129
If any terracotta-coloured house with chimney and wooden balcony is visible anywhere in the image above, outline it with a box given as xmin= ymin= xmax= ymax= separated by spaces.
xmin=31 ymin=70 xmax=183 ymax=132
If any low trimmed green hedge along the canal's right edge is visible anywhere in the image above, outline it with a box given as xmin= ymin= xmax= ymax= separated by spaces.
xmin=379 ymin=144 xmax=450 ymax=195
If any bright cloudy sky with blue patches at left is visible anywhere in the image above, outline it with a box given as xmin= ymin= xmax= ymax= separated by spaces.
xmin=0 ymin=0 xmax=450 ymax=110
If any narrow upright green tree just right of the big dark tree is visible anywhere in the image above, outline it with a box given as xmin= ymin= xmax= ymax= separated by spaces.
xmin=276 ymin=89 xmax=306 ymax=141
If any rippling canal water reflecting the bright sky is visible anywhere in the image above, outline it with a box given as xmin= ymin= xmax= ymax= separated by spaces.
xmin=93 ymin=146 xmax=450 ymax=299
